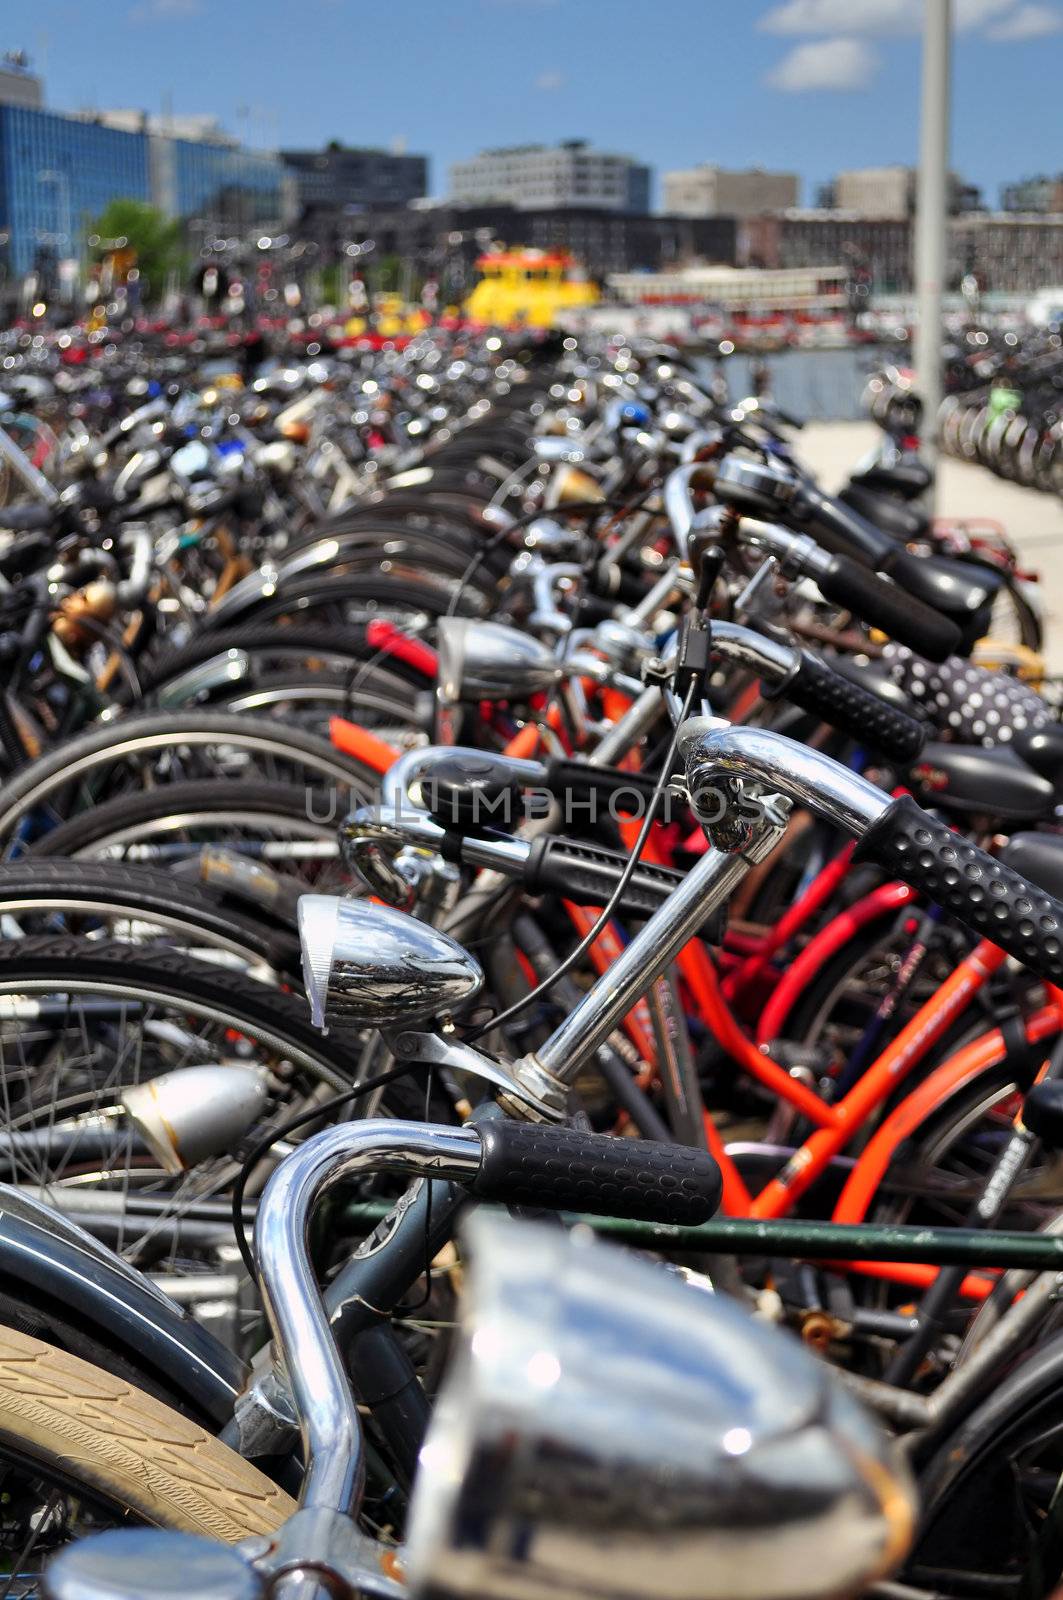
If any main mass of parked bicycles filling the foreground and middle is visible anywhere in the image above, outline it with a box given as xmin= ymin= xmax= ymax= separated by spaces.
xmin=0 ymin=334 xmax=1063 ymax=1600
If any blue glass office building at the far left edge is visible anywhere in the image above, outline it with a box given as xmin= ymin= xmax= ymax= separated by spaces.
xmin=0 ymin=106 xmax=152 ymax=277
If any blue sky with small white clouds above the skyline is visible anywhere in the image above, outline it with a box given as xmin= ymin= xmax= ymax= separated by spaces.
xmin=16 ymin=0 xmax=1063 ymax=203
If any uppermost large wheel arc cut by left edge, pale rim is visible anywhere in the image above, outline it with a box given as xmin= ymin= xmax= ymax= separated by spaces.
xmin=0 ymin=710 xmax=376 ymax=843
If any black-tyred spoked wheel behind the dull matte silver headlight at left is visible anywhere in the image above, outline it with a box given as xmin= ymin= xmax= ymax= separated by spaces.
xmin=0 ymin=938 xmax=377 ymax=1286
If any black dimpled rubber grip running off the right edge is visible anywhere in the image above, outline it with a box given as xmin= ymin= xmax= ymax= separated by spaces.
xmin=853 ymin=795 xmax=1063 ymax=986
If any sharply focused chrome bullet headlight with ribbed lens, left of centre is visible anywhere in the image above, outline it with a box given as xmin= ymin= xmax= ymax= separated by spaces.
xmin=299 ymin=894 xmax=483 ymax=1029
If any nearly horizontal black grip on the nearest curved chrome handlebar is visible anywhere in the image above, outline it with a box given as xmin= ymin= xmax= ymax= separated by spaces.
xmin=469 ymin=1120 xmax=722 ymax=1226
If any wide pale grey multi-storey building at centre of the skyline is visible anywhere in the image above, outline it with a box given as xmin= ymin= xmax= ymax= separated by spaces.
xmin=450 ymin=139 xmax=650 ymax=213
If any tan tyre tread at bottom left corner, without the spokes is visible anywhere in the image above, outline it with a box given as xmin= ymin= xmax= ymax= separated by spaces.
xmin=0 ymin=1326 xmax=296 ymax=1544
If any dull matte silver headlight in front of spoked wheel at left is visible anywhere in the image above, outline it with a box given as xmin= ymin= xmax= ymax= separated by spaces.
xmin=118 ymin=1061 xmax=269 ymax=1174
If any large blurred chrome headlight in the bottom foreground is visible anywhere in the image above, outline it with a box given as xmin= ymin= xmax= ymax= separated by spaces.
xmin=407 ymin=1213 xmax=916 ymax=1600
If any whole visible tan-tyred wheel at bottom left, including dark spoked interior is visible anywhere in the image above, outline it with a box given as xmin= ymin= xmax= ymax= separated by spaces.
xmin=0 ymin=1326 xmax=295 ymax=1600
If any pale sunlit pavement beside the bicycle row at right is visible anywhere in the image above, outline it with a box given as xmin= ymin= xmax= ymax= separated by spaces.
xmin=799 ymin=422 xmax=1063 ymax=674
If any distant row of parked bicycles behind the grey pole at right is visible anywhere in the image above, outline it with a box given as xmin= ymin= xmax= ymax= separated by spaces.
xmin=868 ymin=326 xmax=1063 ymax=494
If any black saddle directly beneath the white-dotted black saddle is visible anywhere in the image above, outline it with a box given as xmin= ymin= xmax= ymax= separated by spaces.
xmin=909 ymin=744 xmax=1055 ymax=822
